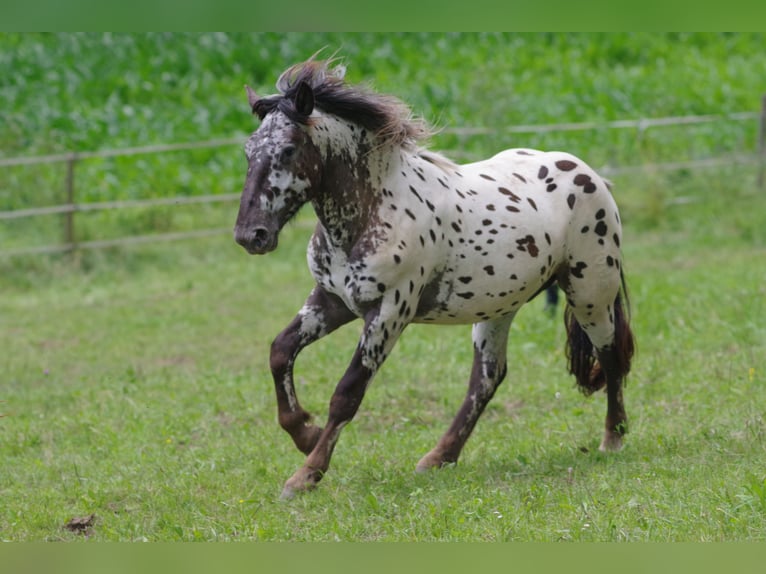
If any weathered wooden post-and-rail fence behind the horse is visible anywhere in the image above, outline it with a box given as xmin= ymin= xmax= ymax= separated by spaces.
xmin=0 ymin=107 xmax=766 ymax=257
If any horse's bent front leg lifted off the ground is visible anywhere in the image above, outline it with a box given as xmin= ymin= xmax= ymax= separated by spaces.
xmin=269 ymin=286 xmax=356 ymax=454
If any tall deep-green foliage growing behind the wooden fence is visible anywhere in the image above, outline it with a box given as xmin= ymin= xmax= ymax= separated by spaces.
xmin=0 ymin=32 xmax=766 ymax=216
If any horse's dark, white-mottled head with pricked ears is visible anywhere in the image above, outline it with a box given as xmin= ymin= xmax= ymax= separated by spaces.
xmin=234 ymin=83 xmax=321 ymax=254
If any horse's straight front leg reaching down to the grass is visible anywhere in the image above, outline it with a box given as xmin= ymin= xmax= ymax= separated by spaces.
xmin=282 ymin=309 xmax=411 ymax=498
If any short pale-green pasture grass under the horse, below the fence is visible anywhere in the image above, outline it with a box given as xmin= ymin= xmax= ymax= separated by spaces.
xmin=0 ymin=168 xmax=766 ymax=541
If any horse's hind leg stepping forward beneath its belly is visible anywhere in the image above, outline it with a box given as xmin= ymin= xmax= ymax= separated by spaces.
xmin=417 ymin=315 xmax=513 ymax=472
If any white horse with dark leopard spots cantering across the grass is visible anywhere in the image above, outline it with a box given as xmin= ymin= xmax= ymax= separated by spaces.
xmin=235 ymin=59 xmax=633 ymax=497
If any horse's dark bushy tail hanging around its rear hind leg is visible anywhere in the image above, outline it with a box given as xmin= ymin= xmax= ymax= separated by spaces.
xmin=564 ymin=271 xmax=635 ymax=395
